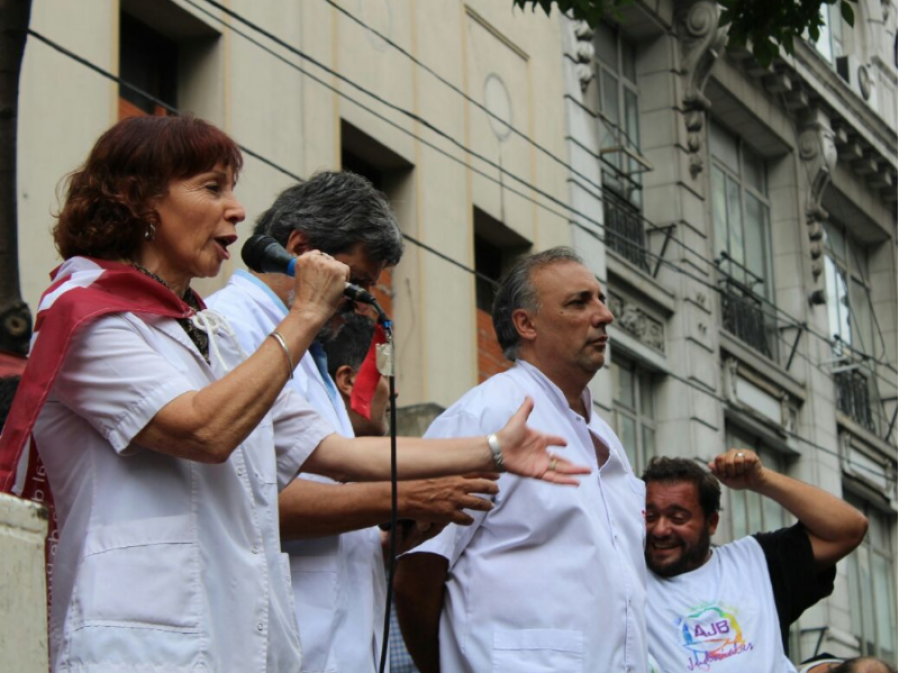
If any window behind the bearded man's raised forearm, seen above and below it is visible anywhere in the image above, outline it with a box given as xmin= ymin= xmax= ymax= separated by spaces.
xmin=726 ymin=425 xmax=787 ymax=540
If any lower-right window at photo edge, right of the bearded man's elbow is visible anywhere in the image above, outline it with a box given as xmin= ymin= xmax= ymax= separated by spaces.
xmin=846 ymin=495 xmax=899 ymax=665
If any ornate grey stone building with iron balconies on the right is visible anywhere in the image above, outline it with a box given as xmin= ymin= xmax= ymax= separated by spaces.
xmin=563 ymin=0 xmax=899 ymax=663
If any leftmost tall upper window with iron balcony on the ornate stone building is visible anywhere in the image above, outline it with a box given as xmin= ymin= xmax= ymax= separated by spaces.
xmin=595 ymin=24 xmax=649 ymax=271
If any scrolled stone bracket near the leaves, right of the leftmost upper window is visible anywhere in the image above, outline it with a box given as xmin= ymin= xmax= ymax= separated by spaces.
xmin=677 ymin=0 xmax=727 ymax=179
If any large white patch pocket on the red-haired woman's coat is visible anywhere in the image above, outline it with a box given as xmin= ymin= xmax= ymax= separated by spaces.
xmin=76 ymin=517 xmax=200 ymax=633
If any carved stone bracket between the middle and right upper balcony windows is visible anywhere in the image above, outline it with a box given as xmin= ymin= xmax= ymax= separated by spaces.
xmin=799 ymin=111 xmax=837 ymax=296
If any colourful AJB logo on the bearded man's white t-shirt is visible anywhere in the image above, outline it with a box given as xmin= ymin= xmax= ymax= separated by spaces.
xmin=677 ymin=605 xmax=754 ymax=671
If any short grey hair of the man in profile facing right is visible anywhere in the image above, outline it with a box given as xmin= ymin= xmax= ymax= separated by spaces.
xmin=493 ymin=248 xmax=584 ymax=362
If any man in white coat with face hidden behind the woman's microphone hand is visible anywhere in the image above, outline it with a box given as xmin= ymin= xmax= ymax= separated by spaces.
xmin=207 ymin=172 xmax=496 ymax=673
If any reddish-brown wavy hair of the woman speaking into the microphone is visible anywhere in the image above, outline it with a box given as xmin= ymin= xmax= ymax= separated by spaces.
xmin=53 ymin=115 xmax=243 ymax=259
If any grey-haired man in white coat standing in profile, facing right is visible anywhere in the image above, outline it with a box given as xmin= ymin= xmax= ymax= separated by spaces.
xmin=397 ymin=248 xmax=648 ymax=673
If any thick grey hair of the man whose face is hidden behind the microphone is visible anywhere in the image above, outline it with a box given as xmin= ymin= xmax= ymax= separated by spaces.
xmin=253 ymin=171 xmax=403 ymax=266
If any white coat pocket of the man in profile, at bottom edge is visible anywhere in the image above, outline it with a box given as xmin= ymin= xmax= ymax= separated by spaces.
xmin=493 ymin=629 xmax=584 ymax=673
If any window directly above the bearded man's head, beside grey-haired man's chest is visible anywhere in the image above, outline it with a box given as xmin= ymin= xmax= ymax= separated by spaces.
xmin=611 ymin=358 xmax=656 ymax=474
